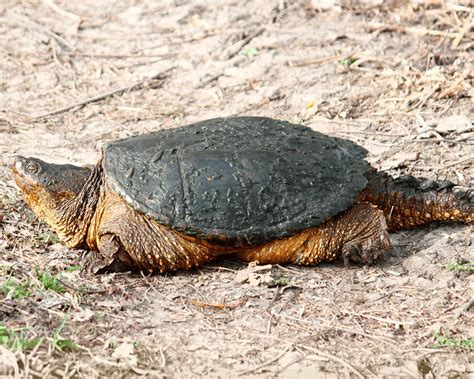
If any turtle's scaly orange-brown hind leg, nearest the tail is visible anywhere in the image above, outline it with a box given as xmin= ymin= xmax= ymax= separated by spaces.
xmin=238 ymin=203 xmax=391 ymax=265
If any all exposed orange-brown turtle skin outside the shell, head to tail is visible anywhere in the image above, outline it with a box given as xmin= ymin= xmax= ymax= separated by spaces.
xmin=13 ymin=157 xmax=474 ymax=272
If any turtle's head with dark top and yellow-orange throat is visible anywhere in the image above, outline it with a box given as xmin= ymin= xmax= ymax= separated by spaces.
xmin=11 ymin=156 xmax=98 ymax=247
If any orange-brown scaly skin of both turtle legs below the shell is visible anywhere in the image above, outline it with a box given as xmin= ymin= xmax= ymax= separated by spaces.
xmin=83 ymin=188 xmax=390 ymax=272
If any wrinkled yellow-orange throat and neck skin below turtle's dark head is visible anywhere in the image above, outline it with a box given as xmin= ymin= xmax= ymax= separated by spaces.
xmin=25 ymin=163 xmax=102 ymax=248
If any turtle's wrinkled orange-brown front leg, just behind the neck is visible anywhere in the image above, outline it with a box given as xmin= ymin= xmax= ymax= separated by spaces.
xmin=87 ymin=191 xmax=222 ymax=273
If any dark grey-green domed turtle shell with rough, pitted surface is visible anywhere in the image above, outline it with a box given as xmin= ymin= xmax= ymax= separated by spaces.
xmin=103 ymin=117 xmax=369 ymax=246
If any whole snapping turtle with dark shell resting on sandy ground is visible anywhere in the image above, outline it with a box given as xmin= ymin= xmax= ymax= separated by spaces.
xmin=12 ymin=117 xmax=474 ymax=272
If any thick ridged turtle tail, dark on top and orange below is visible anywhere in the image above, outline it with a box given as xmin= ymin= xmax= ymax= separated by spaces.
xmin=358 ymin=171 xmax=474 ymax=231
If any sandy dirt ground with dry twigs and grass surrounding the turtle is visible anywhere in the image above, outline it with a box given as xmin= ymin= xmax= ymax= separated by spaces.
xmin=0 ymin=0 xmax=474 ymax=378
